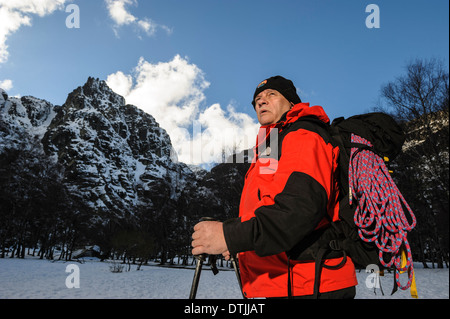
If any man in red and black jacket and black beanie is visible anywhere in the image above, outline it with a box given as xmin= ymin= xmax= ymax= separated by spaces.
xmin=192 ymin=76 xmax=357 ymax=298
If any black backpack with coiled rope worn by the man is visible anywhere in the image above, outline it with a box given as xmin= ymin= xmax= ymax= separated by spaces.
xmin=287 ymin=113 xmax=415 ymax=297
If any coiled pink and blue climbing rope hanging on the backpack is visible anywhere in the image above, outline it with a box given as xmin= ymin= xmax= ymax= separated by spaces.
xmin=349 ymin=134 xmax=416 ymax=290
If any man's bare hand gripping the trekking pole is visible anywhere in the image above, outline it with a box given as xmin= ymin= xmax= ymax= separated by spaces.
xmin=192 ymin=222 xmax=229 ymax=256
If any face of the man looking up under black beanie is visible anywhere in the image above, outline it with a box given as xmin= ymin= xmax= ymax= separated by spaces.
xmin=255 ymin=89 xmax=292 ymax=125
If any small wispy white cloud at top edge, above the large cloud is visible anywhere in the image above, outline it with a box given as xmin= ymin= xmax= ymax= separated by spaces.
xmin=105 ymin=0 xmax=172 ymax=36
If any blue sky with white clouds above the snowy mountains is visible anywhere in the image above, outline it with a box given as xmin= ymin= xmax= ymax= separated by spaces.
xmin=0 ymin=0 xmax=449 ymax=165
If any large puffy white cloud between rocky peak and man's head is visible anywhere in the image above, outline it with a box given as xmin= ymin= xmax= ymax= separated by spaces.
xmin=107 ymin=55 xmax=259 ymax=164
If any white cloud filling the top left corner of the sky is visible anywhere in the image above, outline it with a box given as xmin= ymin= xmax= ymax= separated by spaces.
xmin=0 ymin=0 xmax=70 ymax=63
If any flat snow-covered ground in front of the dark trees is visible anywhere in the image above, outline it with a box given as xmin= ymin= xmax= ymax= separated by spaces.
xmin=0 ymin=257 xmax=449 ymax=299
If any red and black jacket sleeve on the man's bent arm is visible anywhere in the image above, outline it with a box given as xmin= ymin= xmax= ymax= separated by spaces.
xmin=223 ymin=130 xmax=333 ymax=257
